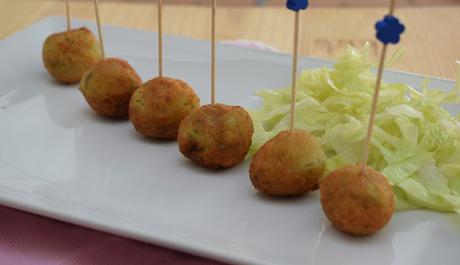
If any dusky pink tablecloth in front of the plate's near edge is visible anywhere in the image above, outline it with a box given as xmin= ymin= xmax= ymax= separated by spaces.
xmin=0 ymin=206 xmax=230 ymax=265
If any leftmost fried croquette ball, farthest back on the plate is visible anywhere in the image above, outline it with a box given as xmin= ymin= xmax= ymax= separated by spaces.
xmin=42 ymin=28 xmax=102 ymax=83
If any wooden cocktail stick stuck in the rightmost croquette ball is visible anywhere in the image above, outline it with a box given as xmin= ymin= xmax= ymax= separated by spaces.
xmin=361 ymin=0 xmax=404 ymax=173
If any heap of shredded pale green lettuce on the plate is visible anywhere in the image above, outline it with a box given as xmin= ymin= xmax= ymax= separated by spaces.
xmin=249 ymin=46 xmax=460 ymax=213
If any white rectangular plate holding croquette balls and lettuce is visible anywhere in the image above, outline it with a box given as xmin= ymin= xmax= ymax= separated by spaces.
xmin=0 ymin=18 xmax=460 ymax=265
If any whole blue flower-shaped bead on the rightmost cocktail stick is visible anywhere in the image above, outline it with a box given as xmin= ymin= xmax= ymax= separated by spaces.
xmin=375 ymin=15 xmax=405 ymax=45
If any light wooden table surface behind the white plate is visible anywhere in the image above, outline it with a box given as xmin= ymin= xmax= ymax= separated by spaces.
xmin=0 ymin=0 xmax=460 ymax=79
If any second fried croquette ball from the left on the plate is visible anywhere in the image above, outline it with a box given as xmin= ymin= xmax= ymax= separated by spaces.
xmin=80 ymin=58 xmax=142 ymax=118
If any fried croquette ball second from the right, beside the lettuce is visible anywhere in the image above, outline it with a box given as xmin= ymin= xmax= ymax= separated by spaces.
xmin=249 ymin=130 xmax=326 ymax=196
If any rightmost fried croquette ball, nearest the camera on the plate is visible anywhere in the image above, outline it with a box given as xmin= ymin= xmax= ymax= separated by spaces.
xmin=320 ymin=165 xmax=394 ymax=235
